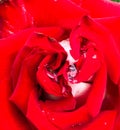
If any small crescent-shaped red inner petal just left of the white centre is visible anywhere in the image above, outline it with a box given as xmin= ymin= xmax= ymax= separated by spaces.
xmin=37 ymin=56 xmax=62 ymax=96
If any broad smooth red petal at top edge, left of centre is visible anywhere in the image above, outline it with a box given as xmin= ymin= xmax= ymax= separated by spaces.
xmin=24 ymin=0 xmax=86 ymax=26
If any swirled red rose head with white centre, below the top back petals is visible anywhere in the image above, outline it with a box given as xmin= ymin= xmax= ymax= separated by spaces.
xmin=0 ymin=16 xmax=120 ymax=130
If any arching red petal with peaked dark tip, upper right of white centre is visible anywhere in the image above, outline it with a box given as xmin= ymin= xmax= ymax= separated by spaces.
xmin=71 ymin=16 xmax=120 ymax=83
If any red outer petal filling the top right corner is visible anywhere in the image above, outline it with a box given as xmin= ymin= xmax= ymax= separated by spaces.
xmin=80 ymin=0 xmax=120 ymax=18
